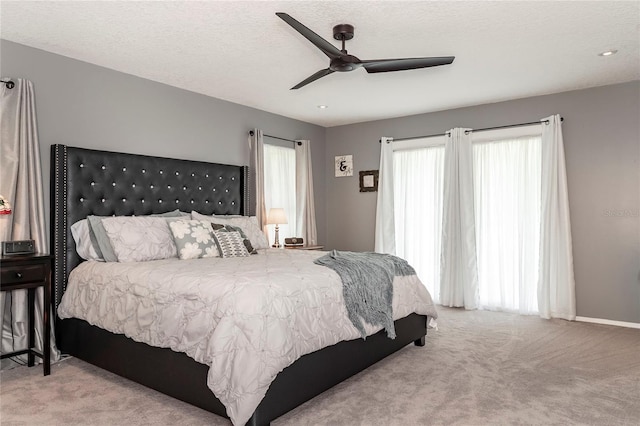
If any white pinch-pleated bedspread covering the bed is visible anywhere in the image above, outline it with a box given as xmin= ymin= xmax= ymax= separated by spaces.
xmin=58 ymin=249 xmax=437 ymax=425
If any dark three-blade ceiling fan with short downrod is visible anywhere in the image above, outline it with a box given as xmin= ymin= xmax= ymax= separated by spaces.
xmin=276 ymin=12 xmax=455 ymax=90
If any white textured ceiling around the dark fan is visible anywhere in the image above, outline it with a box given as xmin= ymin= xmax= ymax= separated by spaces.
xmin=0 ymin=0 xmax=640 ymax=127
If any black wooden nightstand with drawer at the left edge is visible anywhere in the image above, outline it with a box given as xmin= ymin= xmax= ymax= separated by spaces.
xmin=0 ymin=254 xmax=51 ymax=376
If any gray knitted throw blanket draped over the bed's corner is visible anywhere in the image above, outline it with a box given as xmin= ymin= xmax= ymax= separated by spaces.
xmin=314 ymin=250 xmax=416 ymax=339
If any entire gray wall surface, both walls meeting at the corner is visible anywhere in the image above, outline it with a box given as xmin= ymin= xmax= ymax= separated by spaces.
xmin=0 ymin=40 xmax=640 ymax=323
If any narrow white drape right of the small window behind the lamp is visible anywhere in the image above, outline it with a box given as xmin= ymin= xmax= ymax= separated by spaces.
xmin=291 ymin=140 xmax=318 ymax=245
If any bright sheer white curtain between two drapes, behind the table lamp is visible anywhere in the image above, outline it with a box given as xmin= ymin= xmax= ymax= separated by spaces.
xmin=264 ymin=144 xmax=297 ymax=244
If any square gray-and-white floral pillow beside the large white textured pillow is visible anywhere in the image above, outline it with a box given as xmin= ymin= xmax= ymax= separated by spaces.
xmin=169 ymin=220 xmax=220 ymax=260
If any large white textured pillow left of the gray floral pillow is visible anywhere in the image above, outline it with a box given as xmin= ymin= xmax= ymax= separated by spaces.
xmin=102 ymin=216 xmax=178 ymax=262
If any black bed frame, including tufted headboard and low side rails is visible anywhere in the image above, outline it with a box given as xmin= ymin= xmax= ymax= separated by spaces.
xmin=51 ymin=145 xmax=427 ymax=426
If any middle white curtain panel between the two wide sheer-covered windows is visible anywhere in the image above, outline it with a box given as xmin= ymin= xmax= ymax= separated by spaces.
xmin=440 ymin=128 xmax=478 ymax=309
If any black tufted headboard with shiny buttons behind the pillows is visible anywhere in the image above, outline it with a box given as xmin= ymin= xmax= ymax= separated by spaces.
xmin=51 ymin=145 xmax=254 ymax=309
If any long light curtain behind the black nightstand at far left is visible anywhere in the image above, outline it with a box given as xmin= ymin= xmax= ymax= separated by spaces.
xmin=0 ymin=79 xmax=60 ymax=367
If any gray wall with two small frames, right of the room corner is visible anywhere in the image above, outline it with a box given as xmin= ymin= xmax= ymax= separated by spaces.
xmin=325 ymin=81 xmax=640 ymax=323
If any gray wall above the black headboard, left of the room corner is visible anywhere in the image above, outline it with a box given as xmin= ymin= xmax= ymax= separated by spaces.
xmin=0 ymin=40 xmax=326 ymax=243
